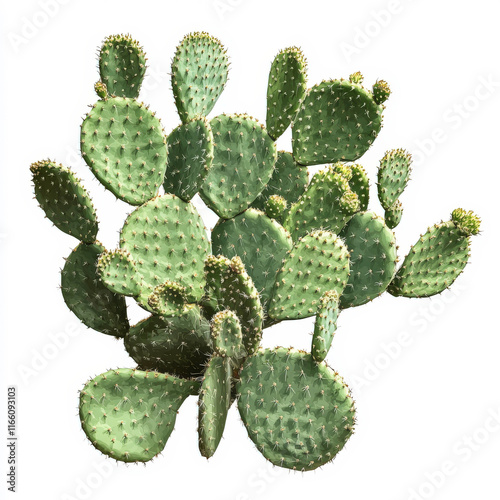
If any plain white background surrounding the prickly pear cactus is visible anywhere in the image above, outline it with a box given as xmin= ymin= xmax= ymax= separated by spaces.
xmin=0 ymin=0 xmax=500 ymax=500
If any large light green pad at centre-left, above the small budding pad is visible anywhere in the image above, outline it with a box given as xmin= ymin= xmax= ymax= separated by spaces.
xmin=120 ymin=194 xmax=210 ymax=302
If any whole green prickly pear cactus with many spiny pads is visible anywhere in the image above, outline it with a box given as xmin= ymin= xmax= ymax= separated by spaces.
xmin=31 ymin=33 xmax=480 ymax=471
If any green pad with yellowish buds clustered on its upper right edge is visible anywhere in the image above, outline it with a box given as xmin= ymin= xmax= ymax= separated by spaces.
xmin=284 ymin=165 xmax=360 ymax=241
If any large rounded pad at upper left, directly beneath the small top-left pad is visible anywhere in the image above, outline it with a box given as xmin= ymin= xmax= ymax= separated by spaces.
xmin=81 ymin=97 xmax=167 ymax=205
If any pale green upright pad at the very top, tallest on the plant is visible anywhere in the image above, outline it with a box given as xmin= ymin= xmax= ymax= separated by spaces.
xmin=172 ymin=33 xmax=229 ymax=122
